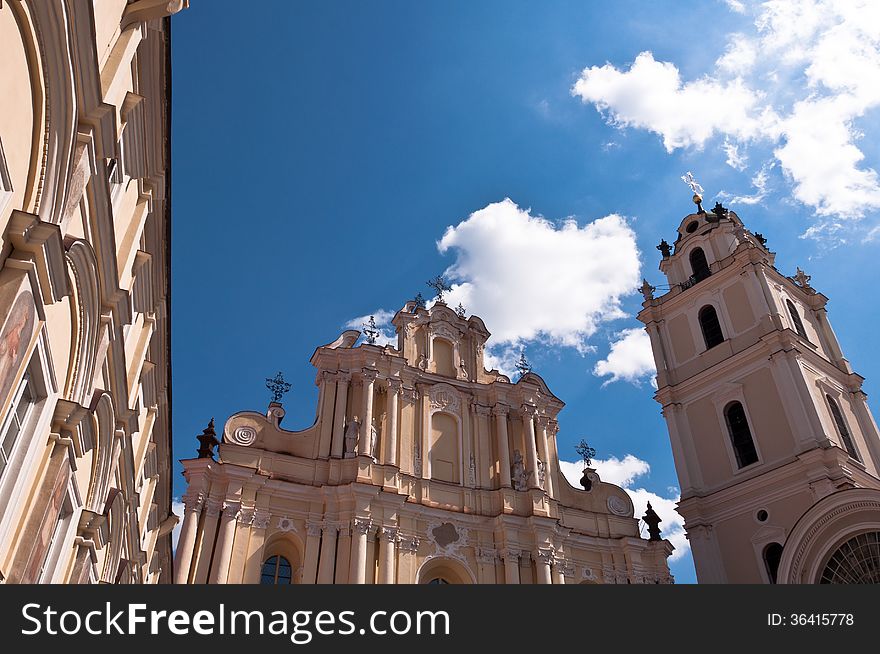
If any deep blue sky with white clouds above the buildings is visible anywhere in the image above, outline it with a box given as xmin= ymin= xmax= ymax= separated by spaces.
xmin=172 ymin=0 xmax=880 ymax=583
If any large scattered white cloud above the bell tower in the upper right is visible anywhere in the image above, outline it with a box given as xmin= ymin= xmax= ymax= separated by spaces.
xmin=572 ymin=0 xmax=880 ymax=234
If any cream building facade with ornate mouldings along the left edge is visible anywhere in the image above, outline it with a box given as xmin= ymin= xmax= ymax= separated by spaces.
xmin=0 ymin=0 xmax=185 ymax=583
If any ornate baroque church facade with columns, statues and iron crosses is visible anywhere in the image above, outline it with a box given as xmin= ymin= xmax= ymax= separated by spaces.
xmin=175 ymin=302 xmax=672 ymax=584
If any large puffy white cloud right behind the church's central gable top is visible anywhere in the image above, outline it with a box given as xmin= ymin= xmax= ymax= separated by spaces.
xmin=437 ymin=199 xmax=639 ymax=356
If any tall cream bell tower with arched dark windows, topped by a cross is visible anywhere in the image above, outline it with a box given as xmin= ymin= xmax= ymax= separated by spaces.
xmin=639 ymin=196 xmax=880 ymax=583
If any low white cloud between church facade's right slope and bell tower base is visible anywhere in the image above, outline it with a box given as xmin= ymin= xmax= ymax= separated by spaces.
xmin=559 ymin=454 xmax=690 ymax=561
